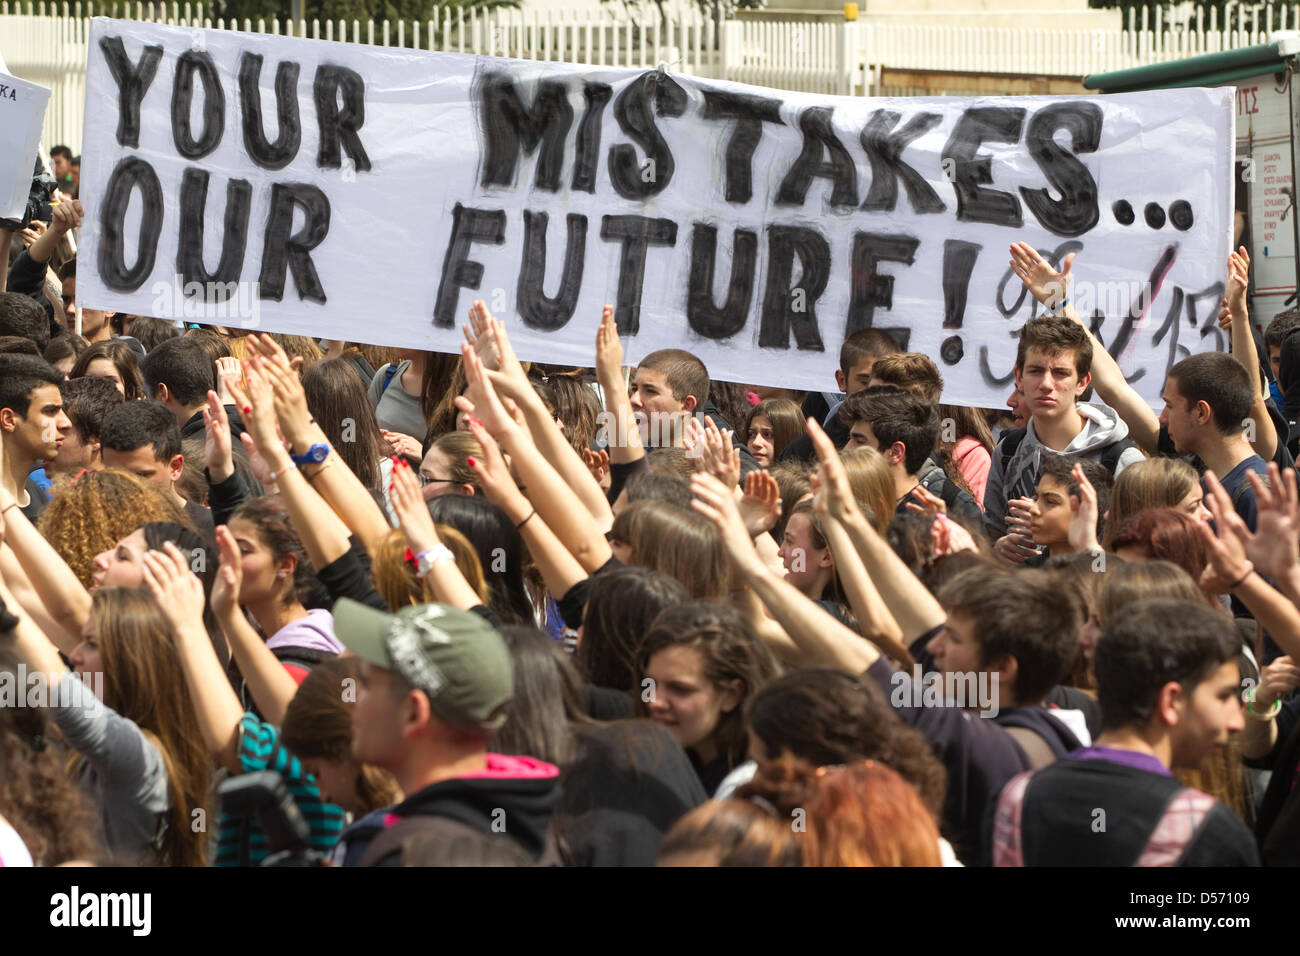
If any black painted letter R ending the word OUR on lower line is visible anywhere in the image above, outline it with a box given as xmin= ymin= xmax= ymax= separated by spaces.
xmin=257 ymin=182 xmax=329 ymax=304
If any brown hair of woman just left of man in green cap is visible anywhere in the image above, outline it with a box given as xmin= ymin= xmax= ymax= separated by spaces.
xmin=280 ymin=657 xmax=402 ymax=813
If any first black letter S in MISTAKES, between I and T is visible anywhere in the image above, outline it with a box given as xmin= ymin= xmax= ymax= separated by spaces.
xmin=610 ymin=72 xmax=686 ymax=200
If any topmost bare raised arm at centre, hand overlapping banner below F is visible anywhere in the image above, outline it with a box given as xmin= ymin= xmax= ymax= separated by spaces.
xmin=464 ymin=299 xmax=614 ymax=535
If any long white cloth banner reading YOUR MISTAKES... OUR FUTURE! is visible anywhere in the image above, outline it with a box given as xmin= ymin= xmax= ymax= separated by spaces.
xmin=78 ymin=20 xmax=1234 ymax=406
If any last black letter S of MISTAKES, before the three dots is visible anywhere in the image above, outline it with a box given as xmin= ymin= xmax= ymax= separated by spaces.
xmin=1021 ymin=100 xmax=1101 ymax=235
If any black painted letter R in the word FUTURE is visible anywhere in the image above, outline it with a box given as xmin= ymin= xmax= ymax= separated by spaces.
xmin=758 ymin=226 xmax=831 ymax=351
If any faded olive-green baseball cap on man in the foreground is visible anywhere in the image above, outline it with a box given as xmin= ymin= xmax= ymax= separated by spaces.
xmin=334 ymin=597 xmax=515 ymax=731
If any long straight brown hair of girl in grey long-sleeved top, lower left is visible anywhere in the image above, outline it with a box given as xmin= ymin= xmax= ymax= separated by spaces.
xmin=91 ymin=588 xmax=212 ymax=866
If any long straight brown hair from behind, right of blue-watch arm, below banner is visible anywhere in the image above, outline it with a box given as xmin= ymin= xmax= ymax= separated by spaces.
xmin=303 ymin=359 xmax=389 ymax=493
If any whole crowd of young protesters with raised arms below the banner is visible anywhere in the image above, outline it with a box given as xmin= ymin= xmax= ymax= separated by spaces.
xmin=0 ymin=178 xmax=1300 ymax=866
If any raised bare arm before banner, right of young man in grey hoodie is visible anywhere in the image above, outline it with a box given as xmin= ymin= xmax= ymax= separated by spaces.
xmin=1011 ymin=242 xmax=1160 ymax=455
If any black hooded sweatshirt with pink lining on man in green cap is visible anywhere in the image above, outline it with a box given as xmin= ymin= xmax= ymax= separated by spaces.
xmin=348 ymin=753 xmax=560 ymax=866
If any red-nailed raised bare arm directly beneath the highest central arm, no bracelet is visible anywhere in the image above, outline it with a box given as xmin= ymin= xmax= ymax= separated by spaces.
xmin=456 ymin=345 xmax=612 ymax=574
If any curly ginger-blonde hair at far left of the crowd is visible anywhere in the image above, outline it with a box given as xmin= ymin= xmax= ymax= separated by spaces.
xmin=36 ymin=468 xmax=196 ymax=588
